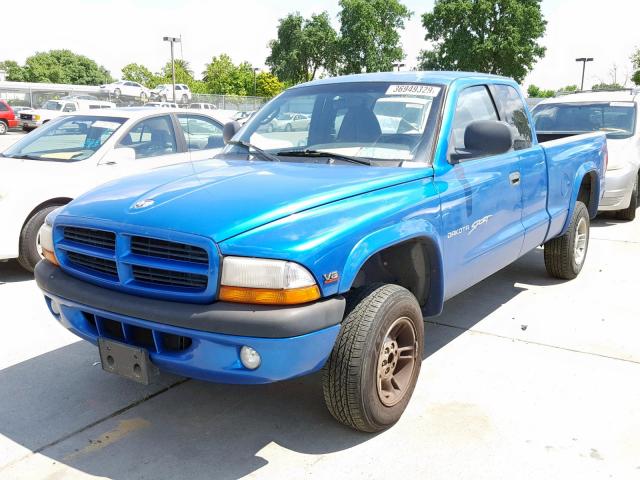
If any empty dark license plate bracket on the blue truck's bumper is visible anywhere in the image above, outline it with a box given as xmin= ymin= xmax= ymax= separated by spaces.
xmin=98 ymin=338 xmax=159 ymax=385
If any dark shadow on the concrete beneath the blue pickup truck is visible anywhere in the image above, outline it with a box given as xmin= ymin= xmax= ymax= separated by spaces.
xmin=0 ymin=251 xmax=553 ymax=480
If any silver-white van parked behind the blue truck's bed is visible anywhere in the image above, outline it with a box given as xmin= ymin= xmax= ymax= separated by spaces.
xmin=532 ymin=91 xmax=640 ymax=220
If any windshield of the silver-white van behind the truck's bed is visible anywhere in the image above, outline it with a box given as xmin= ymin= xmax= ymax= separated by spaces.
xmin=533 ymin=102 xmax=636 ymax=138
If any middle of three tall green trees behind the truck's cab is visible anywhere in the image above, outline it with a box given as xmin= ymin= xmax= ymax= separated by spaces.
xmin=338 ymin=0 xmax=412 ymax=73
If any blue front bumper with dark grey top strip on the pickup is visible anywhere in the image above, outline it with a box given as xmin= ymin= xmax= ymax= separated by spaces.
xmin=35 ymin=261 xmax=345 ymax=384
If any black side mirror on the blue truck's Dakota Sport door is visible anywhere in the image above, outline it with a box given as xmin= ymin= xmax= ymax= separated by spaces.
xmin=449 ymin=120 xmax=513 ymax=163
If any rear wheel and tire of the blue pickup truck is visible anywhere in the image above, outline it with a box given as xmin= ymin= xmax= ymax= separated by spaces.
xmin=544 ymin=202 xmax=590 ymax=280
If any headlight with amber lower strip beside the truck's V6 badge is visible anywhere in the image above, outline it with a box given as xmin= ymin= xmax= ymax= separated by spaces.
xmin=219 ymin=257 xmax=320 ymax=305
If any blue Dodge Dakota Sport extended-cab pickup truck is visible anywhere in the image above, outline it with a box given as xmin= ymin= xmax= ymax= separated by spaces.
xmin=35 ymin=72 xmax=607 ymax=432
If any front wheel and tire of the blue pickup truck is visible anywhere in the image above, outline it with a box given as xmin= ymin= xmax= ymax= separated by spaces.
xmin=323 ymin=284 xmax=424 ymax=432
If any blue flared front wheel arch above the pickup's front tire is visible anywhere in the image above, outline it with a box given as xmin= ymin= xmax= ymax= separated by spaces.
xmin=339 ymin=221 xmax=444 ymax=316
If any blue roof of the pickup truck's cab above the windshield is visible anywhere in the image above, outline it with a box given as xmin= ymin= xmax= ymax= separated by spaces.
xmin=292 ymin=71 xmax=513 ymax=88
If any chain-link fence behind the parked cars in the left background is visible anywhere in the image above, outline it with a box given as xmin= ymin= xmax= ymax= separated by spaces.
xmin=0 ymin=81 xmax=268 ymax=111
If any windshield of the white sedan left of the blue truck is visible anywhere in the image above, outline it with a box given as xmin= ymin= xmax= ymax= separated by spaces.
xmin=2 ymin=115 xmax=127 ymax=162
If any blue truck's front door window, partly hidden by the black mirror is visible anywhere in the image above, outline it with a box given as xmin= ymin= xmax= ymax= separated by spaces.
xmin=449 ymin=85 xmax=498 ymax=156
